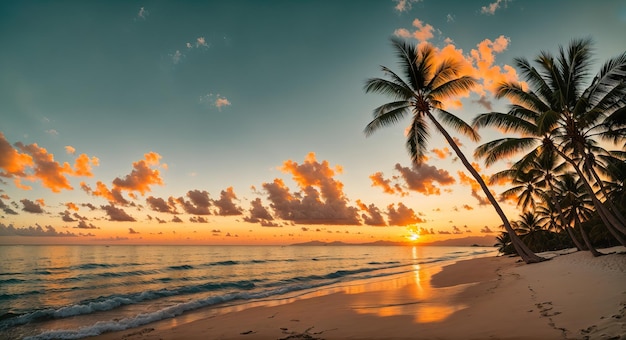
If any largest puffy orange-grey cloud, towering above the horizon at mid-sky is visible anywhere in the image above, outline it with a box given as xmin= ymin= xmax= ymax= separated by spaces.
xmin=263 ymin=152 xmax=360 ymax=225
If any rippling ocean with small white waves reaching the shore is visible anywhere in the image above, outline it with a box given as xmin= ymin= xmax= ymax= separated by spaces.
xmin=0 ymin=245 xmax=496 ymax=339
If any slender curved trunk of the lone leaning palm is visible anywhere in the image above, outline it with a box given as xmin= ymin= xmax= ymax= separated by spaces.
xmin=426 ymin=111 xmax=547 ymax=263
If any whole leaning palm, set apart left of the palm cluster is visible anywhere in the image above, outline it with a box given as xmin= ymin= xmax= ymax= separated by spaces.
xmin=365 ymin=38 xmax=545 ymax=263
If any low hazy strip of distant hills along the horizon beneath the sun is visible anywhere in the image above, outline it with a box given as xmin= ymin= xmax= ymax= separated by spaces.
xmin=291 ymin=236 xmax=496 ymax=247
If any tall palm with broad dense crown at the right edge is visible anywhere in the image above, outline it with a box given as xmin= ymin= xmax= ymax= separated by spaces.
xmin=474 ymin=39 xmax=626 ymax=242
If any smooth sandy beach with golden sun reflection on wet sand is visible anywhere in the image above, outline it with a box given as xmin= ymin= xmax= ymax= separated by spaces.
xmin=95 ymin=247 xmax=626 ymax=340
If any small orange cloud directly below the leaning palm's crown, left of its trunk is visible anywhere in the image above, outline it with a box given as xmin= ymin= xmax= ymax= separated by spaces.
xmin=395 ymin=163 xmax=455 ymax=196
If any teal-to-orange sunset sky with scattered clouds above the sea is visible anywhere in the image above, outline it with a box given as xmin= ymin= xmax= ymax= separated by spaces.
xmin=0 ymin=0 xmax=626 ymax=244
